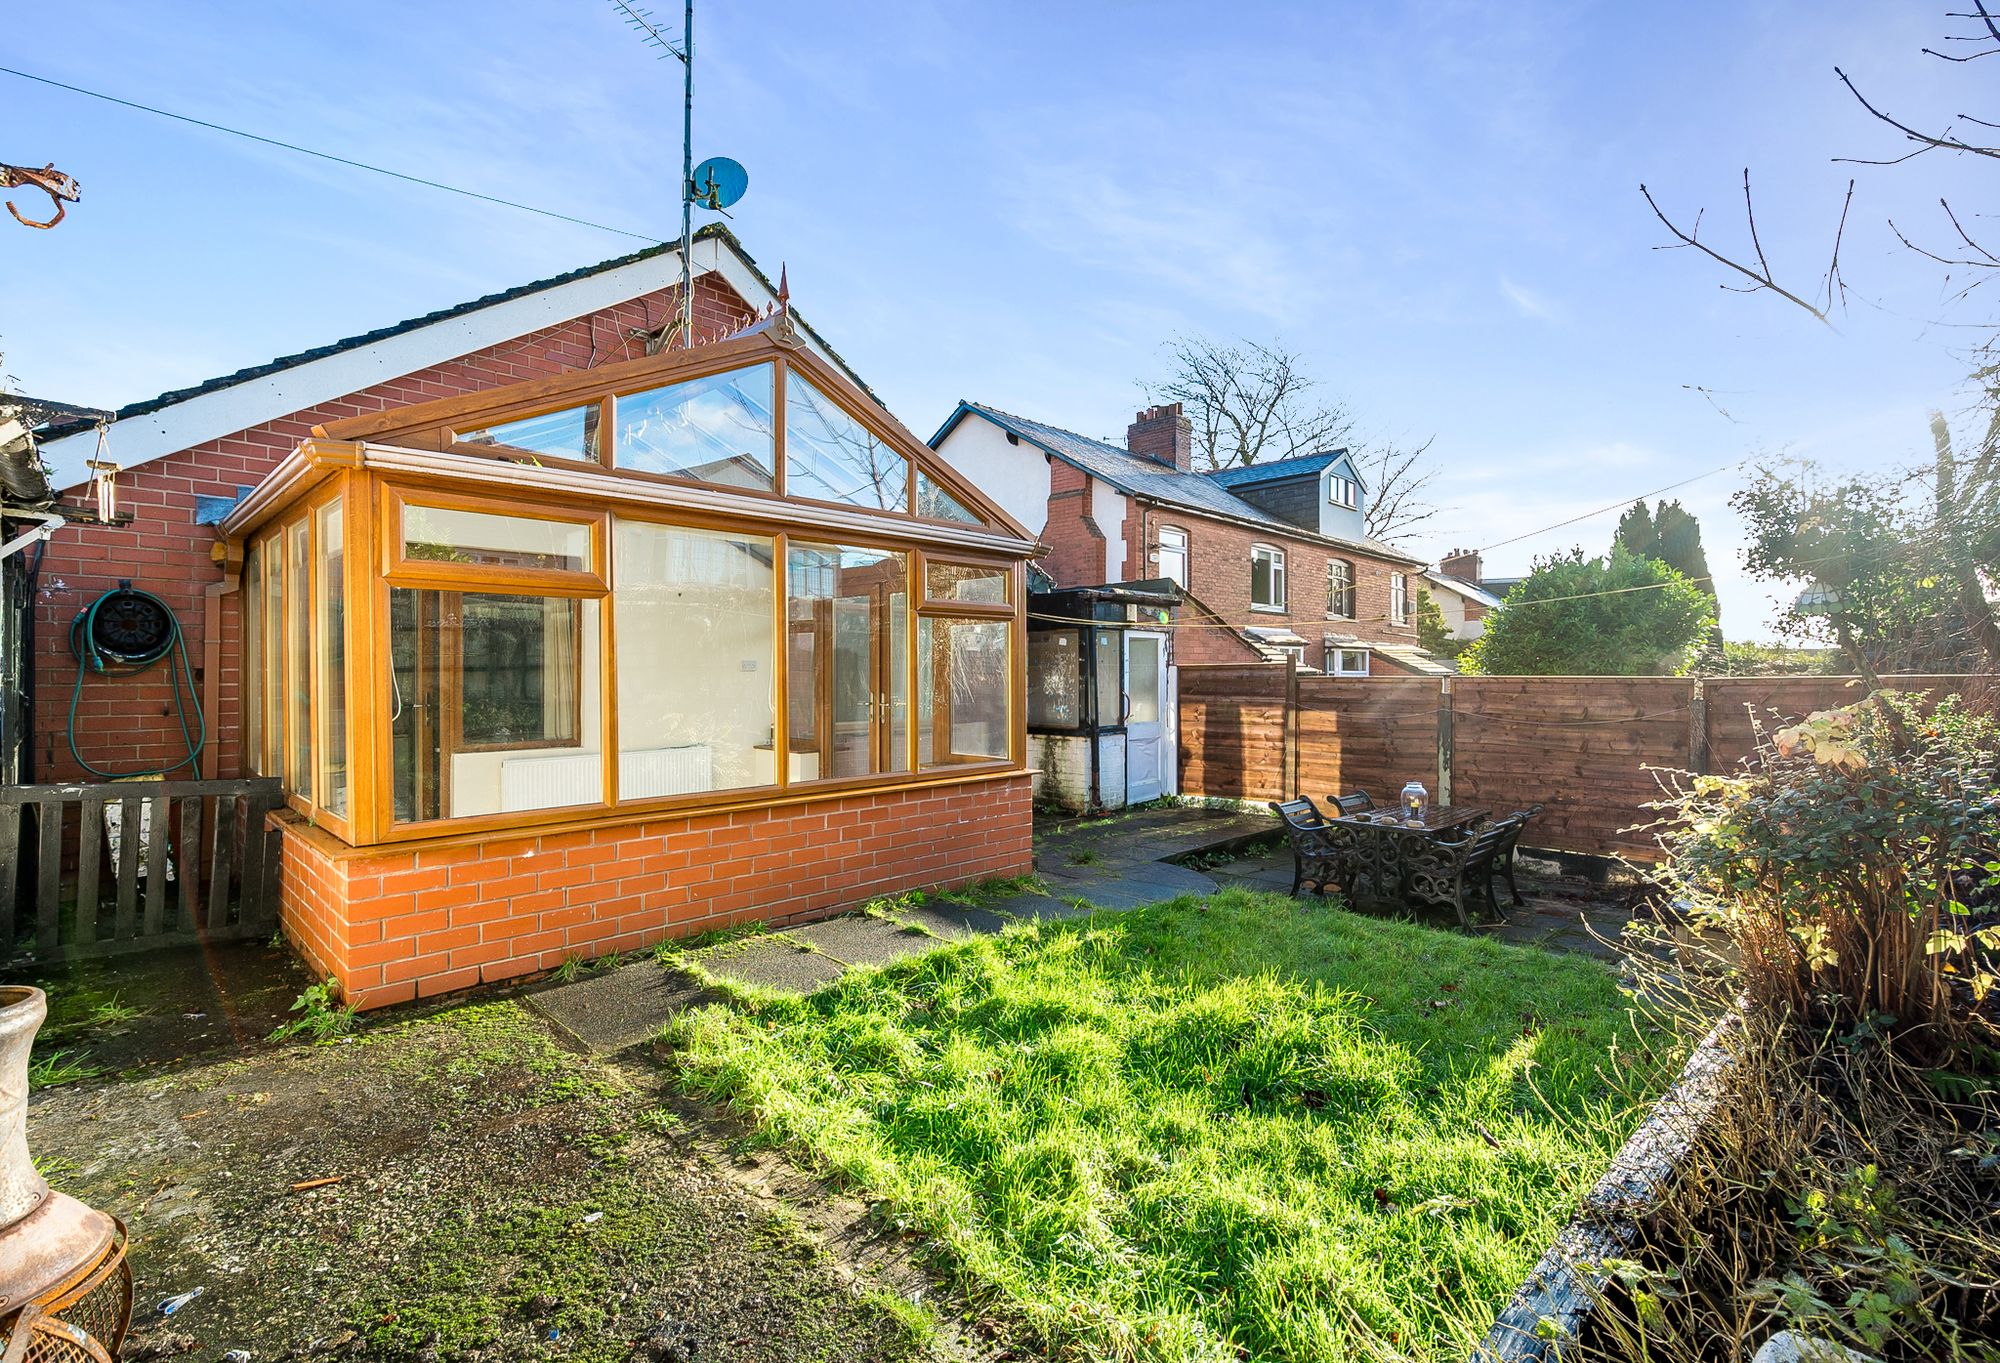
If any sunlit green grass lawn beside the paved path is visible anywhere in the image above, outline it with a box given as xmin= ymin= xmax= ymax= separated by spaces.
xmin=668 ymin=891 xmax=1676 ymax=1361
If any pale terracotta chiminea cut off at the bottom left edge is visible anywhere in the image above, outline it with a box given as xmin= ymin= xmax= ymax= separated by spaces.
xmin=0 ymin=985 xmax=130 ymax=1349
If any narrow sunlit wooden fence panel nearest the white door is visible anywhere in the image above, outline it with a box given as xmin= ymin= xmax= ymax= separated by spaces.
xmin=1180 ymin=664 xmax=1292 ymax=799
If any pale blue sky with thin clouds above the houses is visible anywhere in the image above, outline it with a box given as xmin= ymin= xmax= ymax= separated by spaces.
xmin=0 ymin=0 xmax=1992 ymax=638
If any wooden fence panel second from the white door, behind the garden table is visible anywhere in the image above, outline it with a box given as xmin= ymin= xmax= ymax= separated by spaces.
xmin=1298 ymin=678 xmax=1444 ymax=803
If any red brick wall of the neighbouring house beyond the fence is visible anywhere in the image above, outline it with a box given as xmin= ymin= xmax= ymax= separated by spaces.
xmin=1112 ymin=498 xmax=1418 ymax=668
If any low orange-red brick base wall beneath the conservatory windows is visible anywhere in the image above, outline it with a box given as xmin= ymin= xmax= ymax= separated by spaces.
xmin=280 ymin=775 xmax=1034 ymax=1007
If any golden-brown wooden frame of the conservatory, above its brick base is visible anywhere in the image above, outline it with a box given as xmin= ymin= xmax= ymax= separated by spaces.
xmin=222 ymin=314 xmax=1036 ymax=847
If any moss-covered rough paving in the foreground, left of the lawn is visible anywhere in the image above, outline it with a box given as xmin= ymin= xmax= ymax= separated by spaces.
xmin=30 ymin=1001 xmax=924 ymax=1363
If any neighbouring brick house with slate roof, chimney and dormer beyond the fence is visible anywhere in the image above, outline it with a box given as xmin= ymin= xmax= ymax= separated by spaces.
xmin=930 ymin=402 xmax=1446 ymax=676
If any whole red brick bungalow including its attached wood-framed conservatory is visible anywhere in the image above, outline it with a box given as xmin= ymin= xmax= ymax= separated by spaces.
xmin=15 ymin=228 xmax=1034 ymax=1007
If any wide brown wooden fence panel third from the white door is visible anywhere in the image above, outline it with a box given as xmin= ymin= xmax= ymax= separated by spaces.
xmin=1452 ymin=678 xmax=1694 ymax=859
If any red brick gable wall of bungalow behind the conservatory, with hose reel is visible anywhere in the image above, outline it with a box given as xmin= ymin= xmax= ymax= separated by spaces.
xmin=32 ymin=274 xmax=750 ymax=781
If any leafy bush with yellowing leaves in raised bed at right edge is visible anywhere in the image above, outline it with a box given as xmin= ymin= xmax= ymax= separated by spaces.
xmin=1662 ymin=691 xmax=2000 ymax=1067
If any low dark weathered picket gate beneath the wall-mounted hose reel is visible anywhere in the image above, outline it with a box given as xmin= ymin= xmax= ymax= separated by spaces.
xmin=0 ymin=777 xmax=284 ymax=961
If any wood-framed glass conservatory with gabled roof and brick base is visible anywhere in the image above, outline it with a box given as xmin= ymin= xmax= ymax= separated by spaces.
xmin=224 ymin=314 xmax=1034 ymax=1001
